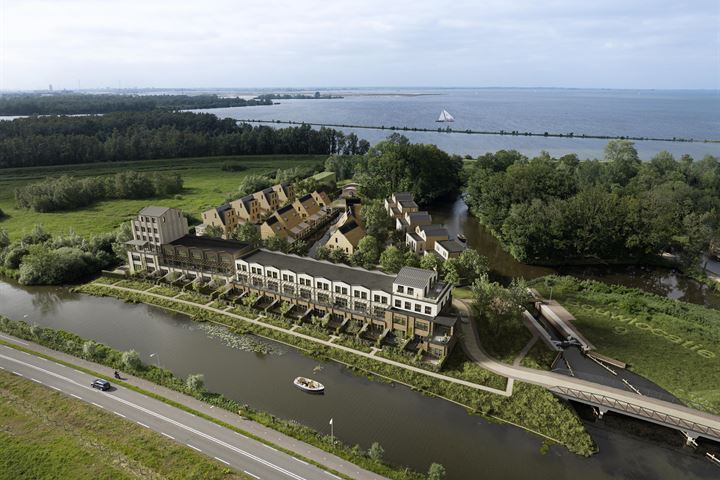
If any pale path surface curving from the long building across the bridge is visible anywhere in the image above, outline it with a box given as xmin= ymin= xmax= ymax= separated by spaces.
xmin=453 ymin=299 xmax=720 ymax=442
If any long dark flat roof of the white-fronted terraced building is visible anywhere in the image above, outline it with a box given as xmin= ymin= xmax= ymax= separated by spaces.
xmin=242 ymin=248 xmax=395 ymax=294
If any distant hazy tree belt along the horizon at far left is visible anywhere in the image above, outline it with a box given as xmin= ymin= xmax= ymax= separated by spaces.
xmin=0 ymin=93 xmax=272 ymax=115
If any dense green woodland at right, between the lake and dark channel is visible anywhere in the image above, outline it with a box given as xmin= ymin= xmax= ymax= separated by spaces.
xmin=466 ymin=140 xmax=720 ymax=266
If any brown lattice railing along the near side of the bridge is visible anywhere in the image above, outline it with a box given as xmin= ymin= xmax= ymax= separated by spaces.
xmin=550 ymin=386 xmax=720 ymax=441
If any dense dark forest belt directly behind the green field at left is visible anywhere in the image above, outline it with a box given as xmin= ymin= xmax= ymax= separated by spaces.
xmin=0 ymin=110 xmax=370 ymax=168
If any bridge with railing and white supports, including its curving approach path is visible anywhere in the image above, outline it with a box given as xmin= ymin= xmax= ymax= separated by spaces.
xmin=453 ymin=299 xmax=720 ymax=444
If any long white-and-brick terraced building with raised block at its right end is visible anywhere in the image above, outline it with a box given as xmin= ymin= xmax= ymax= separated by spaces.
xmin=235 ymin=249 xmax=457 ymax=357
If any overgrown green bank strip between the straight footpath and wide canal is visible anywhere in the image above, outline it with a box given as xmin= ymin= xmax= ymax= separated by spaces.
xmin=73 ymin=283 xmax=595 ymax=455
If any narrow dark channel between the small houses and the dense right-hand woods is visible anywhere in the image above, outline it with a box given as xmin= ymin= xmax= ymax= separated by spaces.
xmin=430 ymin=198 xmax=720 ymax=308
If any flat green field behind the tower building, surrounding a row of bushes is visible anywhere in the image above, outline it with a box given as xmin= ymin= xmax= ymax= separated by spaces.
xmin=0 ymin=155 xmax=326 ymax=240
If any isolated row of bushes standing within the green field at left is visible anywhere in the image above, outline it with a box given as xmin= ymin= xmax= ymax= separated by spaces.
xmin=15 ymin=171 xmax=183 ymax=212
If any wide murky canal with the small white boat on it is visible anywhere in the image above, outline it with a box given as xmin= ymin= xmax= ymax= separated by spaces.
xmin=0 ymin=281 xmax=720 ymax=480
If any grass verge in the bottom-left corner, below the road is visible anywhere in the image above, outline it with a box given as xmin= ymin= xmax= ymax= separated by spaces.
xmin=0 ymin=370 xmax=250 ymax=480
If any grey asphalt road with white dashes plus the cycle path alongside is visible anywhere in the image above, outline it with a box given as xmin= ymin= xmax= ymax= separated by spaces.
xmin=0 ymin=334 xmax=385 ymax=480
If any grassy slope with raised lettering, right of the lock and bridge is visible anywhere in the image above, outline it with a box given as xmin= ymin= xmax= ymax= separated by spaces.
xmin=531 ymin=277 xmax=720 ymax=414
